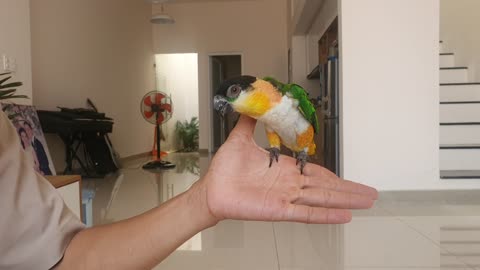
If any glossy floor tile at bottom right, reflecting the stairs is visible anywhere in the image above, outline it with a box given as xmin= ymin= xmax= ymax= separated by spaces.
xmin=380 ymin=191 xmax=480 ymax=269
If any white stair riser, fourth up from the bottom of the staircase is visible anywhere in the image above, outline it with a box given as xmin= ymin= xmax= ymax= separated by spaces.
xmin=440 ymin=83 xmax=480 ymax=102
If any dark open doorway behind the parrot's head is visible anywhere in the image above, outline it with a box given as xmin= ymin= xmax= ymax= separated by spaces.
xmin=209 ymin=54 xmax=242 ymax=152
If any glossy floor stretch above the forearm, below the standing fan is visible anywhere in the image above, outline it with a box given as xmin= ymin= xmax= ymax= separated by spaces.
xmin=83 ymin=153 xmax=209 ymax=225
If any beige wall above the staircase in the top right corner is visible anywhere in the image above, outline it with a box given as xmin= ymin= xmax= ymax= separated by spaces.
xmin=440 ymin=0 xmax=480 ymax=82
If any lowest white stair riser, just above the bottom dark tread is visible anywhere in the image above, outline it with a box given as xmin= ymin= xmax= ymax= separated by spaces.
xmin=440 ymin=146 xmax=480 ymax=170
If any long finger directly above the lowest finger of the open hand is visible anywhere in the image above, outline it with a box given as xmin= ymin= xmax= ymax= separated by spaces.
xmin=292 ymin=188 xmax=374 ymax=209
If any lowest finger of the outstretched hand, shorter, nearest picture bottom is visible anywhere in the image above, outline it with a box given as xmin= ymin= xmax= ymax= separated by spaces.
xmin=284 ymin=204 xmax=352 ymax=224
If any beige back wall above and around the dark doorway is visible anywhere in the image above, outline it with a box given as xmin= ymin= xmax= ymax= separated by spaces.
xmin=153 ymin=0 xmax=288 ymax=149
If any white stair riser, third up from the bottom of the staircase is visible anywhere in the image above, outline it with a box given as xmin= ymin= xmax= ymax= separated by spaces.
xmin=440 ymin=102 xmax=480 ymax=123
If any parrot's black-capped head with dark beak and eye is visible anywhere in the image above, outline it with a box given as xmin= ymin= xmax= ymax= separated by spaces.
xmin=213 ymin=75 xmax=257 ymax=115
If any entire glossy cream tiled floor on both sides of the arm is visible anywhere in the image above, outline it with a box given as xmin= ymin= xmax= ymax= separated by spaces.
xmin=84 ymin=154 xmax=480 ymax=270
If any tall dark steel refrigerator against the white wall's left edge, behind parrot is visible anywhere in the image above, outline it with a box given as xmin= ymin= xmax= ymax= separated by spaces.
xmin=319 ymin=52 xmax=340 ymax=175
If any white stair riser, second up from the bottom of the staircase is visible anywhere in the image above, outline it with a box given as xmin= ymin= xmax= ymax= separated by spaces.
xmin=440 ymin=125 xmax=480 ymax=145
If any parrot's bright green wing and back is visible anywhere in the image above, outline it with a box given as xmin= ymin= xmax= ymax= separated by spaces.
xmin=264 ymin=77 xmax=320 ymax=133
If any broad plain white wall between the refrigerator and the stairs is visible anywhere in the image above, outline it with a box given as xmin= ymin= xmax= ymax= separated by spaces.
xmin=340 ymin=0 xmax=480 ymax=190
